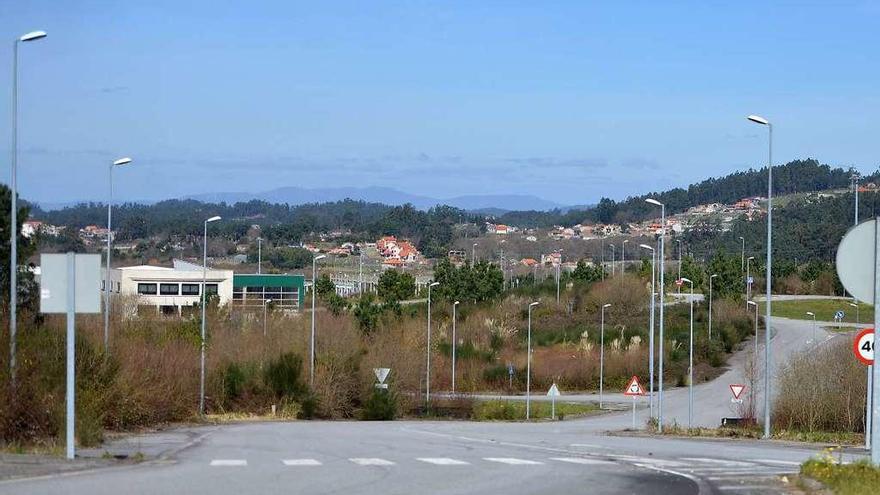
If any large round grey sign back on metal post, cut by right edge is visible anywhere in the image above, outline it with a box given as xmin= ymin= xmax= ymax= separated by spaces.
xmin=837 ymin=221 xmax=880 ymax=466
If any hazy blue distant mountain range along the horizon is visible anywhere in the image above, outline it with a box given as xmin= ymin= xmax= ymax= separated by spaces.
xmin=185 ymin=186 xmax=568 ymax=212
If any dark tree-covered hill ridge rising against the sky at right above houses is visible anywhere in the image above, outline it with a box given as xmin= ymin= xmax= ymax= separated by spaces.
xmin=499 ymin=159 xmax=878 ymax=226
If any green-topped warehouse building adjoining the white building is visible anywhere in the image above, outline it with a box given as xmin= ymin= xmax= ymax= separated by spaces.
xmin=232 ymin=273 xmax=306 ymax=311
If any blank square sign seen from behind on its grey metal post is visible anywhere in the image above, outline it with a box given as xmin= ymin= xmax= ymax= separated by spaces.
xmin=40 ymin=253 xmax=101 ymax=459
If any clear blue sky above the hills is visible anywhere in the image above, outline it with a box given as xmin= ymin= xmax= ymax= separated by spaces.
xmin=0 ymin=0 xmax=880 ymax=204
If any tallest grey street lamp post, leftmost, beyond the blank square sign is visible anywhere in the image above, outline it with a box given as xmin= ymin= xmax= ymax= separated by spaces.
xmin=9 ymin=31 xmax=46 ymax=384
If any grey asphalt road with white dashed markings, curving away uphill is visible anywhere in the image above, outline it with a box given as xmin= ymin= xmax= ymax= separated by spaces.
xmin=0 ymin=308 xmax=858 ymax=495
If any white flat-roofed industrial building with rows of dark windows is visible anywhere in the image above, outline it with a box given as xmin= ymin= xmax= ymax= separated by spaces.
xmin=101 ymin=260 xmax=233 ymax=315
